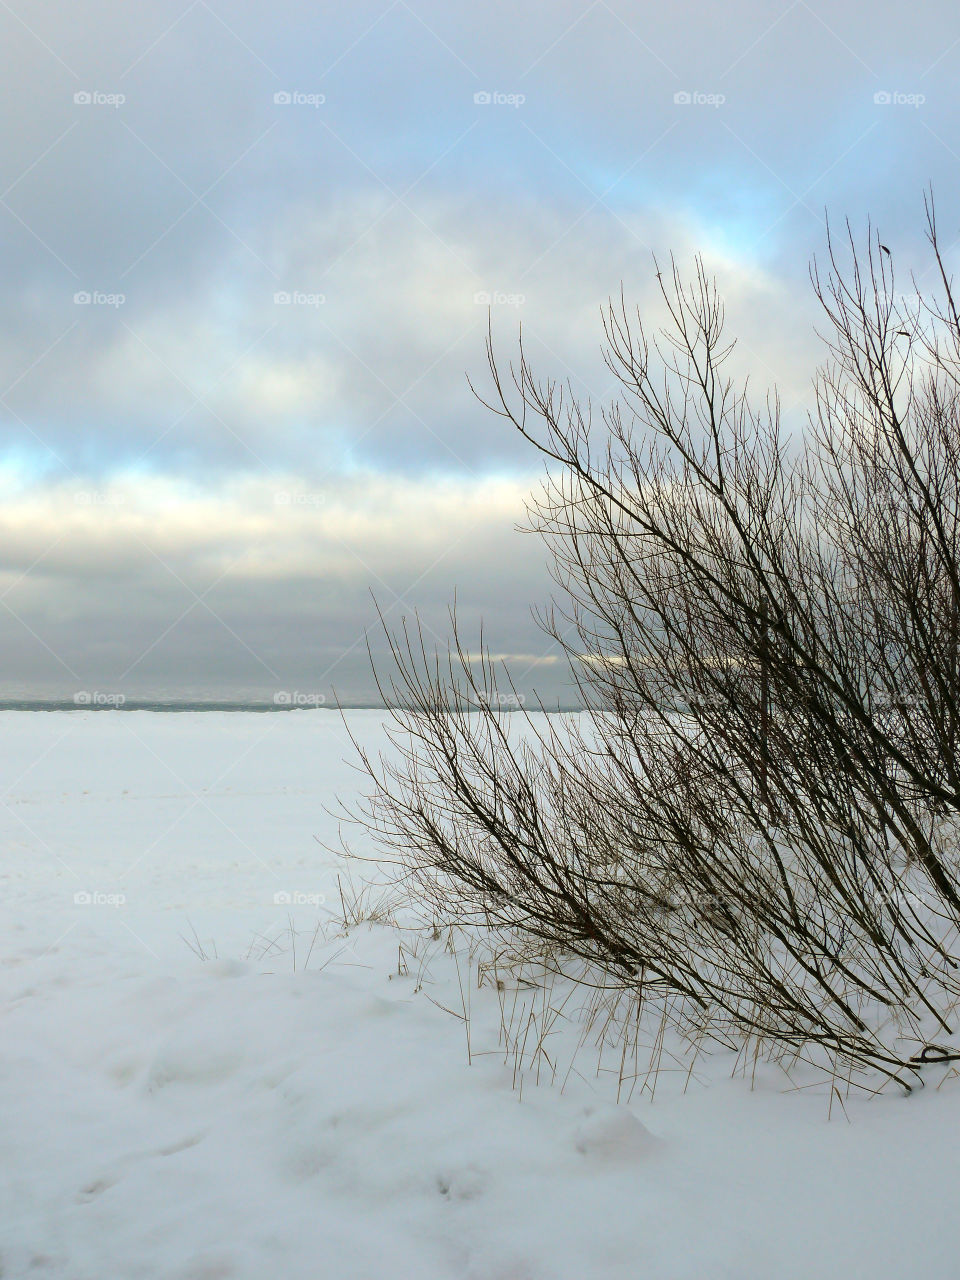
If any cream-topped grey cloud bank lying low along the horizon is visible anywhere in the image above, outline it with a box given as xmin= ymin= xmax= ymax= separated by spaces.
xmin=0 ymin=475 xmax=568 ymax=698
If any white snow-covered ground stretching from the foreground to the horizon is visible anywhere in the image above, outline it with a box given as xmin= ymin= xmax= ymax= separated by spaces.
xmin=0 ymin=712 xmax=960 ymax=1280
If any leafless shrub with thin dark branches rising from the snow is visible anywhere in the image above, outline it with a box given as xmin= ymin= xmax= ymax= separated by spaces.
xmin=353 ymin=205 xmax=960 ymax=1088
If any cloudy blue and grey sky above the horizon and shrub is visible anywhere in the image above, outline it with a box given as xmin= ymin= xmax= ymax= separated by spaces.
xmin=0 ymin=0 xmax=960 ymax=705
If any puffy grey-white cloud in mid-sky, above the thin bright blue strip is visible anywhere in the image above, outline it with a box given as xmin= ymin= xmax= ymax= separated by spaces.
xmin=0 ymin=190 xmax=829 ymax=477
